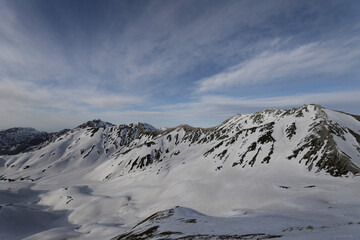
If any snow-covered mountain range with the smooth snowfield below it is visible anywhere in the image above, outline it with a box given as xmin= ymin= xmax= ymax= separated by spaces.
xmin=0 ymin=105 xmax=360 ymax=239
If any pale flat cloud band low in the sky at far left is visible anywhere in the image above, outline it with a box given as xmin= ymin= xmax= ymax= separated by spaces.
xmin=0 ymin=81 xmax=146 ymax=118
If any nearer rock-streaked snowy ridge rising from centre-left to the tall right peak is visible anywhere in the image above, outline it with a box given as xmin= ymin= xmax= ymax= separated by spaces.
xmin=107 ymin=105 xmax=360 ymax=176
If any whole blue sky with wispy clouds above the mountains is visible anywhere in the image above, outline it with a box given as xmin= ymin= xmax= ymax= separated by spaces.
xmin=0 ymin=0 xmax=360 ymax=131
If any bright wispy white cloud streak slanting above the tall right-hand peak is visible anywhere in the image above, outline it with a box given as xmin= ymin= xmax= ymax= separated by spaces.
xmin=197 ymin=39 xmax=360 ymax=92
